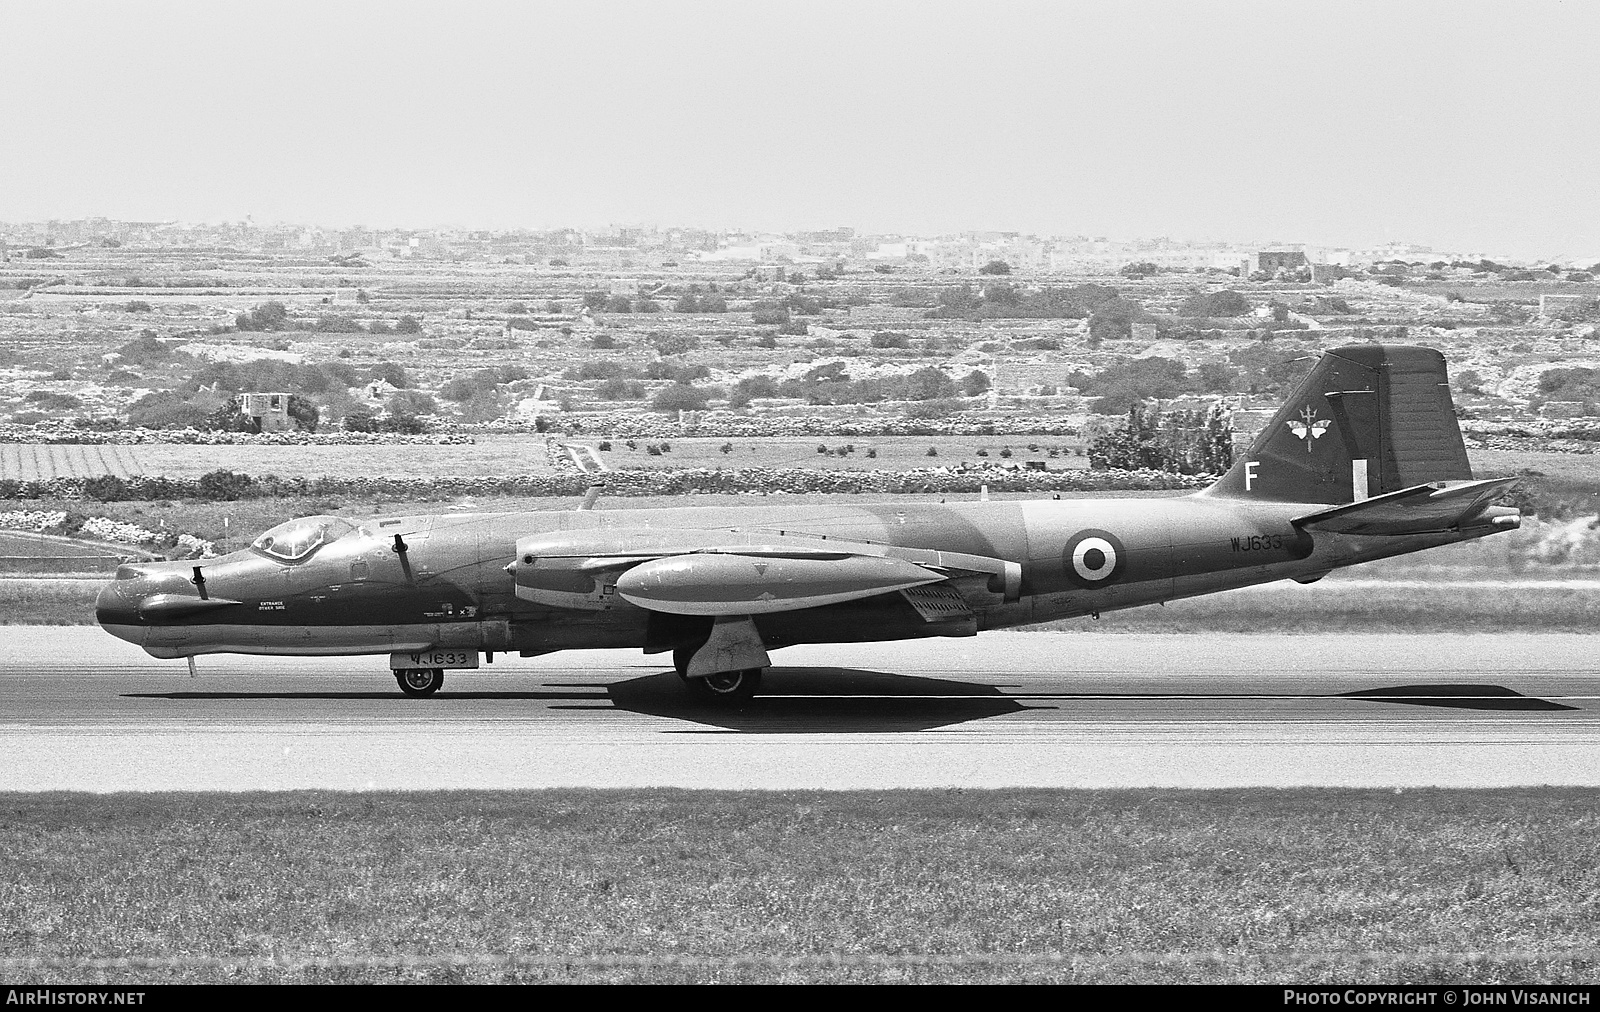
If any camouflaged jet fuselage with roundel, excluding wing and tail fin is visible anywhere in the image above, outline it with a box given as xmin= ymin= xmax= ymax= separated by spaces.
xmin=98 ymin=493 xmax=1514 ymax=658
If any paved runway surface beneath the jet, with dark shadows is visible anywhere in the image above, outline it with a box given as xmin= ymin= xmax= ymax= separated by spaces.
xmin=0 ymin=626 xmax=1600 ymax=791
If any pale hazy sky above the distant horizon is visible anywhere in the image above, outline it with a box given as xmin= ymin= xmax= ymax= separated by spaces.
xmin=0 ymin=0 xmax=1600 ymax=256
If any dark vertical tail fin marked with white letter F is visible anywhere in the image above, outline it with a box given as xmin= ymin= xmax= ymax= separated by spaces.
xmin=1206 ymin=344 xmax=1472 ymax=503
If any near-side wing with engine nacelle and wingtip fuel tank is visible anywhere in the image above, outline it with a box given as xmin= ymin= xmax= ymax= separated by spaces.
xmin=506 ymin=527 xmax=1021 ymax=611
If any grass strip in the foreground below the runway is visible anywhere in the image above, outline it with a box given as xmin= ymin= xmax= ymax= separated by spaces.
xmin=0 ymin=789 xmax=1600 ymax=983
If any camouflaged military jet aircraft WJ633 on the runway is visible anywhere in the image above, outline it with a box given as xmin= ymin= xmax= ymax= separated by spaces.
xmin=96 ymin=344 xmax=1520 ymax=703
